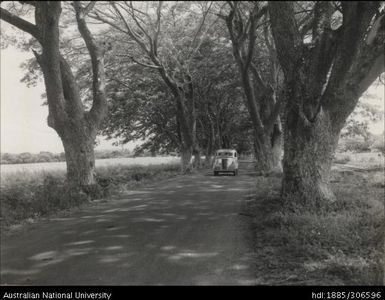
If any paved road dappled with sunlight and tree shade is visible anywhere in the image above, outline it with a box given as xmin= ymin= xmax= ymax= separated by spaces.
xmin=1 ymin=163 xmax=255 ymax=285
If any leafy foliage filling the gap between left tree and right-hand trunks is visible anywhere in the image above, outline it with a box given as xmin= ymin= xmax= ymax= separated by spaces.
xmin=77 ymin=3 xmax=255 ymax=154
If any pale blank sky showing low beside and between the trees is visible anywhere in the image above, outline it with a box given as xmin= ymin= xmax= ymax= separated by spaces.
xmin=0 ymin=28 xmax=385 ymax=153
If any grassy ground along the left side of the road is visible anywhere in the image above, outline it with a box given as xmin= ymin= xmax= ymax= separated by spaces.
xmin=0 ymin=164 xmax=180 ymax=228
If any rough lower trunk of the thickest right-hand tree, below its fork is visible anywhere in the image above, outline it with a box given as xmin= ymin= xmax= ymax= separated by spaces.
xmin=282 ymin=109 xmax=340 ymax=208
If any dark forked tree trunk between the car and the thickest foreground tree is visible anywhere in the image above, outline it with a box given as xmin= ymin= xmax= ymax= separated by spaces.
xmin=224 ymin=2 xmax=282 ymax=174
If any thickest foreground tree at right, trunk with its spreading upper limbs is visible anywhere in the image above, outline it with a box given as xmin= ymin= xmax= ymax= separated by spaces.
xmin=269 ymin=1 xmax=385 ymax=207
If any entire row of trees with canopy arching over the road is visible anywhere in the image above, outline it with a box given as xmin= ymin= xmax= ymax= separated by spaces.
xmin=1 ymin=1 xmax=385 ymax=206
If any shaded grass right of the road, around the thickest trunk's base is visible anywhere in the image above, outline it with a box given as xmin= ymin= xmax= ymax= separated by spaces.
xmin=247 ymin=170 xmax=384 ymax=285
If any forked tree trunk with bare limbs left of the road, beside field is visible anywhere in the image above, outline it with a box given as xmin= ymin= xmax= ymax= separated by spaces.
xmin=1 ymin=1 xmax=107 ymax=191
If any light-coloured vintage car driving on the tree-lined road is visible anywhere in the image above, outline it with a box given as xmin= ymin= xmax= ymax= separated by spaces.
xmin=213 ymin=149 xmax=238 ymax=176
